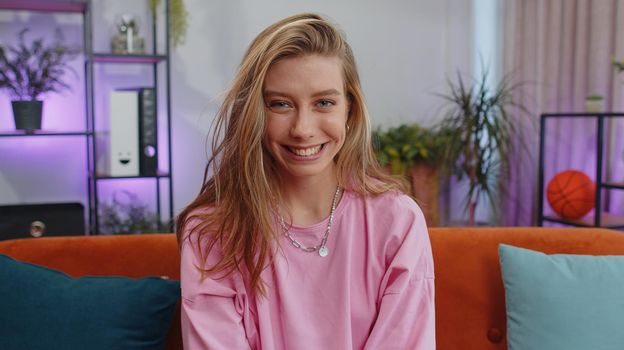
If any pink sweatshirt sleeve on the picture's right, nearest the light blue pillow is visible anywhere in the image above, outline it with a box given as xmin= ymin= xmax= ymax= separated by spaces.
xmin=364 ymin=199 xmax=435 ymax=350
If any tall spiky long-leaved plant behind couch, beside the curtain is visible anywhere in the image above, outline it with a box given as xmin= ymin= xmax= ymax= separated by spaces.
xmin=439 ymin=70 xmax=527 ymax=225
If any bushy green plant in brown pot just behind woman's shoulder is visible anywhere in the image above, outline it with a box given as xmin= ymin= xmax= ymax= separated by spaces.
xmin=373 ymin=124 xmax=447 ymax=226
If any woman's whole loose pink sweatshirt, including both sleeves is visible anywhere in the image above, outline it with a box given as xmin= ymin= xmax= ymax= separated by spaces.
xmin=181 ymin=191 xmax=435 ymax=350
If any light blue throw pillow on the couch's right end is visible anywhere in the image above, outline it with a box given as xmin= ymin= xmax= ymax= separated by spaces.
xmin=499 ymin=244 xmax=624 ymax=350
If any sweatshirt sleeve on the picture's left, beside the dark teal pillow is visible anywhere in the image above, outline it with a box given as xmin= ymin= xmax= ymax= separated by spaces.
xmin=180 ymin=230 xmax=255 ymax=350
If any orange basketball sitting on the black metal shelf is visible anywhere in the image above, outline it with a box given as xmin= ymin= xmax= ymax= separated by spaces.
xmin=546 ymin=170 xmax=596 ymax=220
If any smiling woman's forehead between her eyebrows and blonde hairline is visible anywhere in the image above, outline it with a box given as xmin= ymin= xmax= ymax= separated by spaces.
xmin=263 ymin=55 xmax=344 ymax=93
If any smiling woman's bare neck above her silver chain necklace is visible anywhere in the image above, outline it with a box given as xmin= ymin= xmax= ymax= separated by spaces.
xmin=281 ymin=170 xmax=338 ymax=226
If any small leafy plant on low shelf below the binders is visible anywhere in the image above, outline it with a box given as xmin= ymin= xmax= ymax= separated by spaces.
xmin=100 ymin=191 xmax=166 ymax=234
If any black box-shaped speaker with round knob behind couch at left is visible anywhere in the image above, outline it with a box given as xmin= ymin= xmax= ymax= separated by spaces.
xmin=0 ymin=203 xmax=85 ymax=240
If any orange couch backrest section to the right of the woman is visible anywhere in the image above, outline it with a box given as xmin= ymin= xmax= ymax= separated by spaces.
xmin=429 ymin=227 xmax=624 ymax=350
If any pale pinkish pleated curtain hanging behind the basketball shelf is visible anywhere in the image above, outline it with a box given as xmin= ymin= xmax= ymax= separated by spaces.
xmin=503 ymin=0 xmax=624 ymax=226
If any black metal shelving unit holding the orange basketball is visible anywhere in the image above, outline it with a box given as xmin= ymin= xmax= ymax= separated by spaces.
xmin=537 ymin=112 xmax=624 ymax=230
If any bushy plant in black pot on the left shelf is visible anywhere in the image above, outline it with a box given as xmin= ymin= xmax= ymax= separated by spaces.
xmin=0 ymin=29 xmax=79 ymax=130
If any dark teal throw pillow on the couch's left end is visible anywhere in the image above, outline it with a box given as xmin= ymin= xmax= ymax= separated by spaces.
xmin=0 ymin=254 xmax=180 ymax=350
